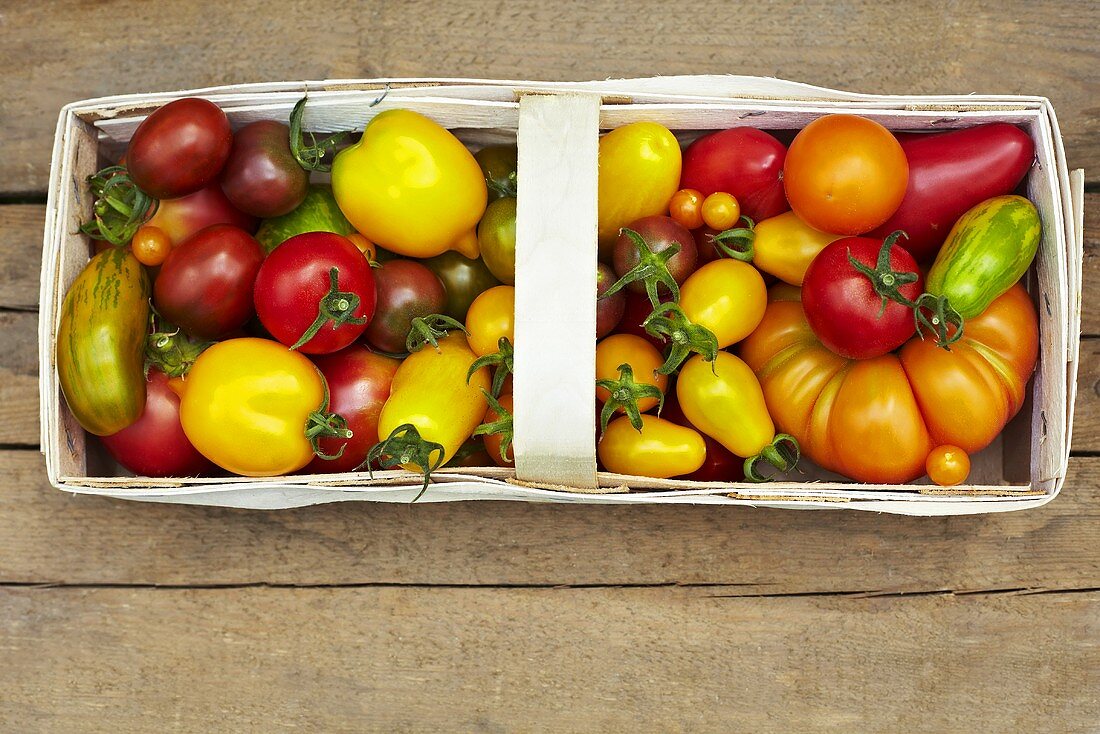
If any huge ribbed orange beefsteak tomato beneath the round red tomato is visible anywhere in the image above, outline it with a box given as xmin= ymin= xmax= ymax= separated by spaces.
xmin=740 ymin=285 xmax=1038 ymax=484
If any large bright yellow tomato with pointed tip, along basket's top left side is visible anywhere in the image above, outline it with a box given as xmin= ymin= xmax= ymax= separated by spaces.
xmin=332 ymin=110 xmax=488 ymax=258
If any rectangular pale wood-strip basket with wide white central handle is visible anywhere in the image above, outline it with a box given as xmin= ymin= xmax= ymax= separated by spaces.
xmin=40 ymin=76 xmax=1084 ymax=515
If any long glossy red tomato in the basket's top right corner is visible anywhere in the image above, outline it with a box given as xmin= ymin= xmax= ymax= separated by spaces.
xmin=870 ymin=122 xmax=1035 ymax=262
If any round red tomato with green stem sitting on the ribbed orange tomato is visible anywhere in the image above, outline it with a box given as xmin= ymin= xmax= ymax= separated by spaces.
xmin=802 ymin=237 xmax=924 ymax=360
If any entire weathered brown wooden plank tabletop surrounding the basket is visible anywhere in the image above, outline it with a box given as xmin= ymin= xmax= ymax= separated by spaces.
xmin=0 ymin=0 xmax=1100 ymax=733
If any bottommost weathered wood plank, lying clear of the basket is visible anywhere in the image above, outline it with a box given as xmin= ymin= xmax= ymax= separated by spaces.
xmin=0 ymin=585 xmax=1100 ymax=734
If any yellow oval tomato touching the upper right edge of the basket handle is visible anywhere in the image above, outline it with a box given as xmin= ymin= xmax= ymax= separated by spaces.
xmin=598 ymin=122 xmax=681 ymax=254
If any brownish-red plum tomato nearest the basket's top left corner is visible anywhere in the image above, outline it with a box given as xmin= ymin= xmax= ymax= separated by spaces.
xmin=127 ymin=97 xmax=233 ymax=199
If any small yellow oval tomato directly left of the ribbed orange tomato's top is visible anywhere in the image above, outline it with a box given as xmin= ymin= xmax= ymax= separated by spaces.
xmin=680 ymin=258 xmax=768 ymax=349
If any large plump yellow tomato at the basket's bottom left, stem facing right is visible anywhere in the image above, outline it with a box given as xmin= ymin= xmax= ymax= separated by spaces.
xmin=176 ymin=338 xmax=325 ymax=476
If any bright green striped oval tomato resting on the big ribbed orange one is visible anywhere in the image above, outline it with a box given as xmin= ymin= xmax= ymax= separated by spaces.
xmin=925 ymin=196 xmax=1042 ymax=319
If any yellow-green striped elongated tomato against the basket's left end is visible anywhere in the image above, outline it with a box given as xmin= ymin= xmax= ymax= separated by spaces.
xmin=57 ymin=248 xmax=150 ymax=436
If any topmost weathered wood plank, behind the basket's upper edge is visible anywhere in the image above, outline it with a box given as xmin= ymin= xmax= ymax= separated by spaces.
xmin=0 ymin=0 xmax=1100 ymax=194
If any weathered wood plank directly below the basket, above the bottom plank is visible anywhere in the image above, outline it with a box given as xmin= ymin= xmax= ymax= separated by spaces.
xmin=0 ymin=451 xmax=1100 ymax=593
